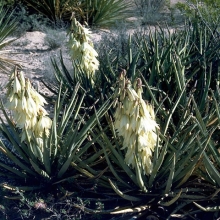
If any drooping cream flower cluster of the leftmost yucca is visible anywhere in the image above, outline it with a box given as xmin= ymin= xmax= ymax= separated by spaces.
xmin=6 ymin=68 xmax=52 ymax=142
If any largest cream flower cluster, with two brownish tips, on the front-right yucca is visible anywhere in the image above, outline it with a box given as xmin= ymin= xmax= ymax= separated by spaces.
xmin=114 ymin=73 xmax=159 ymax=174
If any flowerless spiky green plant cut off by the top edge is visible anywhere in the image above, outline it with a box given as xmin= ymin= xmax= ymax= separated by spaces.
xmin=26 ymin=0 xmax=131 ymax=26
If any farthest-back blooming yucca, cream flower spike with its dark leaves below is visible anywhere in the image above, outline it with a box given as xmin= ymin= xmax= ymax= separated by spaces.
xmin=43 ymin=18 xmax=110 ymax=106
